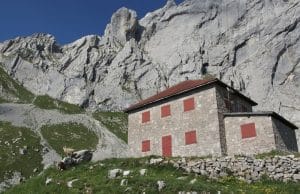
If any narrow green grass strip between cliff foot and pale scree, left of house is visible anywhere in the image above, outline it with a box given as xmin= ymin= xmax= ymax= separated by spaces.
xmin=33 ymin=95 xmax=84 ymax=114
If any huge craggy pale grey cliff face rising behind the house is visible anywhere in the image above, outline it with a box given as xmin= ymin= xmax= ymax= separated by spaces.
xmin=0 ymin=0 xmax=300 ymax=132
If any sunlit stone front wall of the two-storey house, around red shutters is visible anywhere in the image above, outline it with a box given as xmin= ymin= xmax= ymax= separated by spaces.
xmin=128 ymin=86 xmax=221 ymax=157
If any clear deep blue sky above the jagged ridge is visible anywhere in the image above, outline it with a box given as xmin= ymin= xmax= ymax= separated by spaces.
xmin=0 ymin=0 xmax=183 ymax=44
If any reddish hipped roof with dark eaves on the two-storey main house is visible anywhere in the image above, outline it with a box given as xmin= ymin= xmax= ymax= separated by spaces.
xmin=124 ymin=78 xmax=257 ymax=112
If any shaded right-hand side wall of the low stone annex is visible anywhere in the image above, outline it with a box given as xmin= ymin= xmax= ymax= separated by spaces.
xmin=272 ymin=118 xmax=298 ymax=152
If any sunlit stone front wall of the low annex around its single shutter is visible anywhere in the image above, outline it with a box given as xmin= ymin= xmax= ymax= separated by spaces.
xmin=224 ymin=116 xmax=276 ymax=155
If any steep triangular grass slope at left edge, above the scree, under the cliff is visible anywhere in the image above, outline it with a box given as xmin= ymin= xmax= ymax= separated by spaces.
xmin=0 ymin=64 xmax=34 ymax=103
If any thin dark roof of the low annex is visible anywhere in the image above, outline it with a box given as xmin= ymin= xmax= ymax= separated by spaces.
xmin=224 ymin=111 xmax=298 ymax=129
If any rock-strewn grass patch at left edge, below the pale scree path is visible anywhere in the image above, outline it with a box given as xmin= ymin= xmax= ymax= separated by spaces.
xmin=0 ymin=121 xmax=42 ymax=182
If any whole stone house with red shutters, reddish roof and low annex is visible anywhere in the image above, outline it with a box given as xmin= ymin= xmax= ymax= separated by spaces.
xmin=125 ymin=79 xmax=298 ymax=157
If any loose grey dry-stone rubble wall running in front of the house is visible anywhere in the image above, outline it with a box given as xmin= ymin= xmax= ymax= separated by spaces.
xmin=154 ymin=155 xmax=300 ymax=183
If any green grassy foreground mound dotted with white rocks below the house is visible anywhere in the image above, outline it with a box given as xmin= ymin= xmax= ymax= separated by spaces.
xmin=6 ymin=158 xmax=300 ymax=194
